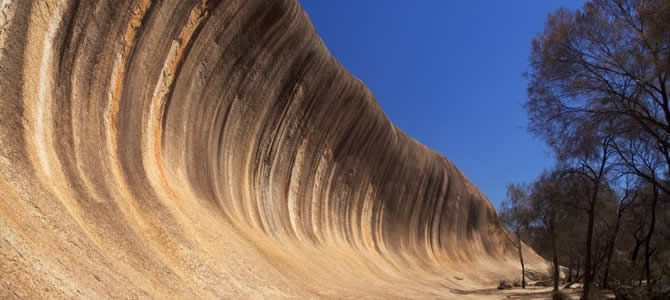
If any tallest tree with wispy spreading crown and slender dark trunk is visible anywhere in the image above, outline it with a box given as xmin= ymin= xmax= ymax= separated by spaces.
xmin=525 ymin=0 xmax=670 ymax=299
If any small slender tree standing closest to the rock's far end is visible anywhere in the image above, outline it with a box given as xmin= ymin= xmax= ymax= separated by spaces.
xmin=500 ymin=184 xmax=530 ymax=289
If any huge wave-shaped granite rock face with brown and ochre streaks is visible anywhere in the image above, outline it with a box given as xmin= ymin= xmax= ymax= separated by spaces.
xmin=0 ymin=0 xmax=545 ymax=299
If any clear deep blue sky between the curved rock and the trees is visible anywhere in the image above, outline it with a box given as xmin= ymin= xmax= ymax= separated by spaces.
xmin=300 ymin=0 xmax=583 ymax=207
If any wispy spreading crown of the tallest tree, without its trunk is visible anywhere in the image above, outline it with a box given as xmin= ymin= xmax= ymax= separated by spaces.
xmin=527 ymin=0 xmax=670 ymax=192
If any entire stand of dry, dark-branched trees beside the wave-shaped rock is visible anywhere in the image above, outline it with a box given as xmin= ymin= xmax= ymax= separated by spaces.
xmin=502 ymin=0 xmax=670 ymax=299
